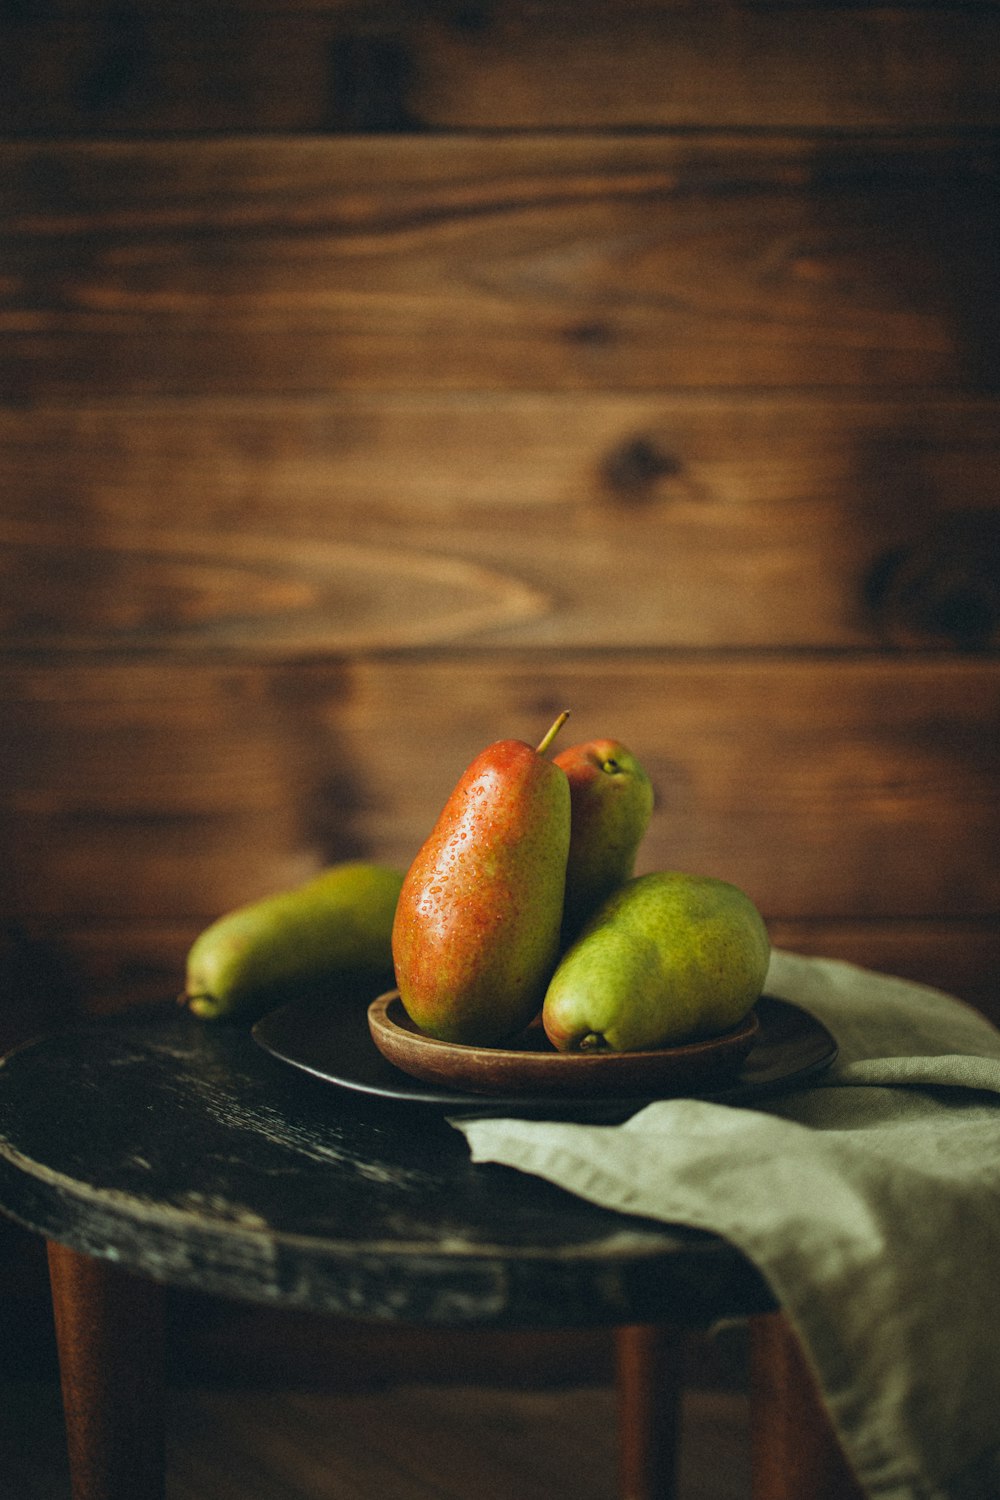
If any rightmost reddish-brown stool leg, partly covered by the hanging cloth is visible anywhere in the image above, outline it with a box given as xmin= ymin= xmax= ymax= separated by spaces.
xmin=750 ymin=1313 xmax=865 ymax=1500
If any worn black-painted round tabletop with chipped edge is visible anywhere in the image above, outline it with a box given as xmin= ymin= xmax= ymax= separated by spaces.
xmin=0 ymin=1002 xmax=774 ymax=1328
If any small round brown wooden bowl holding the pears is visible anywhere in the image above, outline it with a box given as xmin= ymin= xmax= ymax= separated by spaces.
xmin=367 ymin=990 xmax=759 ymax=1098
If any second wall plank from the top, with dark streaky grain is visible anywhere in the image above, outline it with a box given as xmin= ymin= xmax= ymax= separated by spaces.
xmin=0 ymin=135 xmax=1000 ymax=401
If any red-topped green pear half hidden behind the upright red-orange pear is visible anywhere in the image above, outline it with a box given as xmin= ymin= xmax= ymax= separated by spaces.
xmin=553 ymin=740 xmax=652 ymax=947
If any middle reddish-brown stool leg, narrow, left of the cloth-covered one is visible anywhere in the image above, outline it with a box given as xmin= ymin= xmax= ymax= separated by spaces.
xmin=615 ymin=1323 xmax=684 ymax=1500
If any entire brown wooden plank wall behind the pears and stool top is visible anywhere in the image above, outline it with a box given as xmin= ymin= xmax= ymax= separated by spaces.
xmin=0 ymin=0 xmax=1000 ymax=1038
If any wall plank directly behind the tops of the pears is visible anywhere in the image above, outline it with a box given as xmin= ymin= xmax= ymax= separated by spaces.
xmin=0 ymin=653 xmax=1000 ymax=921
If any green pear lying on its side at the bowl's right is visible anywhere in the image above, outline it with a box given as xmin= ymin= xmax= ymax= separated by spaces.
xmin=541 ymin=870 xmax=771 ymax=1052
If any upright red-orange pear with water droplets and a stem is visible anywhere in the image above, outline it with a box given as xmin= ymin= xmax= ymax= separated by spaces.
xmin=393 ymin=714 xmax=570 ymax=1047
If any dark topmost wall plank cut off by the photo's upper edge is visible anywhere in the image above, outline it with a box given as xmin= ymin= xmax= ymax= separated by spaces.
xmin=0 ymin=0 xmax=1000 ymax=134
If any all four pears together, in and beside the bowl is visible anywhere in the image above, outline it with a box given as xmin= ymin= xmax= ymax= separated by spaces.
xmin=180 ymin=713 xmax=771 ymax=1052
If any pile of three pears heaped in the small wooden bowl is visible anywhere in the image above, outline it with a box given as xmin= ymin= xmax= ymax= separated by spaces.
xmin=391 ymin=713 xmax=771 ymax=1052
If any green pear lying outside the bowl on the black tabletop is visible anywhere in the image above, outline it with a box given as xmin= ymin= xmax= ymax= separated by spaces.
xmin=180 ymin=860 xmax=403 ymax=1020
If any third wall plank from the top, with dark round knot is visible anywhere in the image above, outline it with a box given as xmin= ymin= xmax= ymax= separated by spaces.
xmin=0 ymin=393 xmax=1000 ymax=657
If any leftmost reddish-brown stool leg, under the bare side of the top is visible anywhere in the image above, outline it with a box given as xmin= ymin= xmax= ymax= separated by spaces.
xmin=48 ymin=1244 xmax=163 ymax=1500
